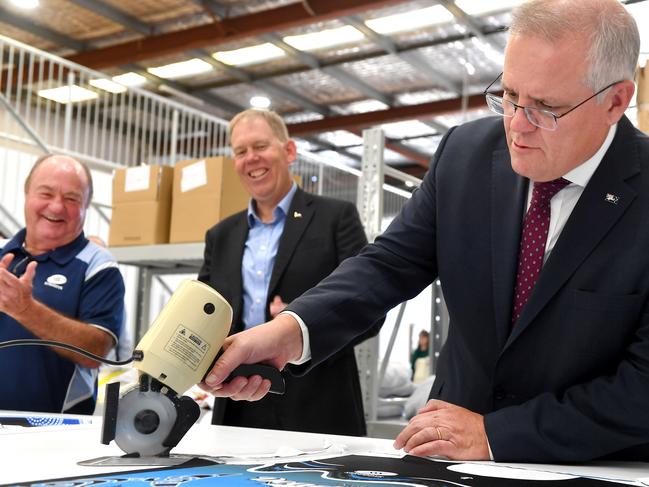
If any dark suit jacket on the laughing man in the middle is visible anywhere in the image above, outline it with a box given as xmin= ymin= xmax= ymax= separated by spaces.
xmin=198 ymin=189 xmax=381 ymax=436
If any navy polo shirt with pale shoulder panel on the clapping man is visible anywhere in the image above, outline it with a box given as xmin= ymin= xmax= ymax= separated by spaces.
xmin=0 ymin=229 xmax=124 ymax=412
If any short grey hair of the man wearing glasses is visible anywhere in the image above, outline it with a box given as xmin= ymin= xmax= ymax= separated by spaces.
xmin=509 ymin=0 xmax=640 ymax=96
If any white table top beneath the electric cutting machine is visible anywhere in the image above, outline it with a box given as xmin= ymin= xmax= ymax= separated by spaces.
xmin=0 ymin=411 xmax=649 ymax=485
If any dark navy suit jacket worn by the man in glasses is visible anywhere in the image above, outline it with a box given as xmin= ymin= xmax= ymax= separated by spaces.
xmin=289 ymin=118 xmax=649 ymax=462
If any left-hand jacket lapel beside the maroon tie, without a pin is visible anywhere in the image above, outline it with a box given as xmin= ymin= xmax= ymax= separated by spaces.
xmin=490 ymin=149 xmax=527 ymax=346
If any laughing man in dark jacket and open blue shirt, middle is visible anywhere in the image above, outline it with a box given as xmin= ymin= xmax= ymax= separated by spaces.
xmin=199 ymin=109 xmax=367 ymax=435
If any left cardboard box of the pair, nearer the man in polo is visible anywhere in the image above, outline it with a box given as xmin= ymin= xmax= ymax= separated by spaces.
xmin=108 ymin=165 xmax=173 ymax=246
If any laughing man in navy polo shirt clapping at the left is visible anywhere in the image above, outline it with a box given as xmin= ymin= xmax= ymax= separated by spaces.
xmin=0 ymin=155 xmax=124 ymax=414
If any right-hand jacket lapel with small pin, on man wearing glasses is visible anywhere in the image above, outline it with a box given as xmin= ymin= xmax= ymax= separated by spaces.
xmin=509 ymin=119 xmax=640 ymax=342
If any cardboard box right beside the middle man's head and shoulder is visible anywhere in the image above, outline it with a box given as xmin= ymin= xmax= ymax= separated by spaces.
xmin=169 ymin=157 xmax=250 ymax=243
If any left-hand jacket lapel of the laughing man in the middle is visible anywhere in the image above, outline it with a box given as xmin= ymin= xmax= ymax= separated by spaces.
xmin=227 ymin=212 xmax=248 ymax=333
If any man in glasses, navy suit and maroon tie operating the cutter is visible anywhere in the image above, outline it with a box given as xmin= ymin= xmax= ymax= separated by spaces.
xmin=202 ymin=0 xmax=649 ymax=462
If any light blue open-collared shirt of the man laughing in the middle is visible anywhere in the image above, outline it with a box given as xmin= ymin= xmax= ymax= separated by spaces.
xmin=241 ymin=183 xmax=297 ymax=328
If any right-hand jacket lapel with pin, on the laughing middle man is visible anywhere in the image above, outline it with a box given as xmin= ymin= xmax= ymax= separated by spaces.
xmin=268 ymin=188 xmax=314 ymax=299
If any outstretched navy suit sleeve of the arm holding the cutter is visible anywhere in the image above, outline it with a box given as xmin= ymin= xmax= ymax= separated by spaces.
xmin=287 ymin=130 xmax=453 ymax=372
